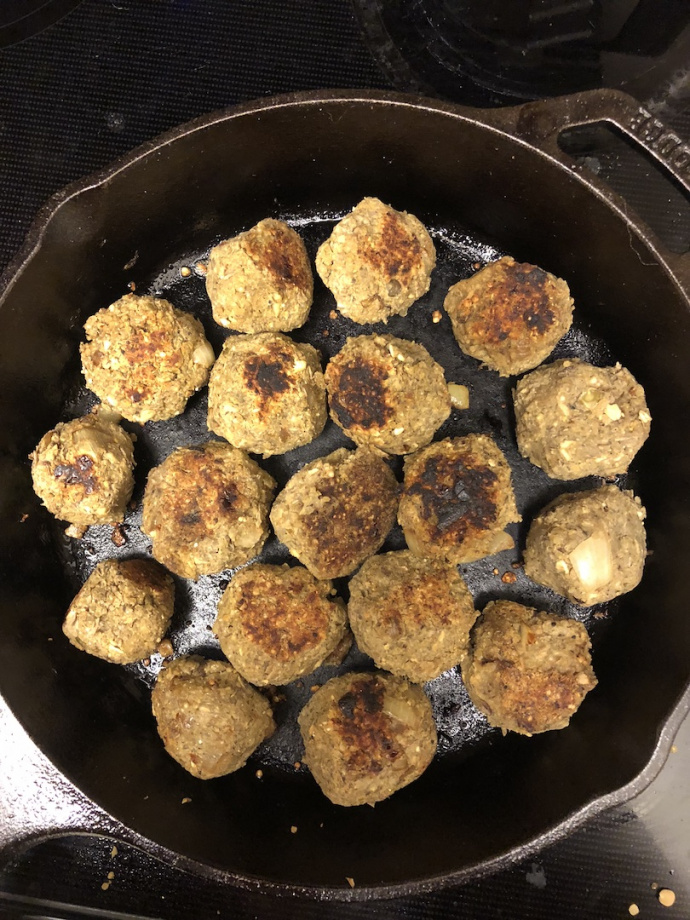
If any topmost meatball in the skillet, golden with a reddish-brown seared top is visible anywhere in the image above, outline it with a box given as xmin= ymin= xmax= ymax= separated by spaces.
xmin=316 ymin=198 xmax=436 ymax=323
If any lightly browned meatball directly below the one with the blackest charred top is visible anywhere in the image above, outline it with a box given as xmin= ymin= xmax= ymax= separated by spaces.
xmin=348 ymin=550 xmax=477 ymax=683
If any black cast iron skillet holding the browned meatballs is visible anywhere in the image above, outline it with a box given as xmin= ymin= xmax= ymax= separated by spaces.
xmin=0 ymin=91 xmax=690 ymax=897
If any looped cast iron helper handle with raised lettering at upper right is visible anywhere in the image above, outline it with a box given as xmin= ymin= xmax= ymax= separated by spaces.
xmin=499 ymin=89 xmax=690 ymax=292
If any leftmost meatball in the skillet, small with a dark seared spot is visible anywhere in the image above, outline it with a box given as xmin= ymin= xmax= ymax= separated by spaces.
xmin=31 ymin=407 xmax=134 ymax=528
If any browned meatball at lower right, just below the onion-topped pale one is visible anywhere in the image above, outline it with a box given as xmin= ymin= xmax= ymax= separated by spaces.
xmin=462 ymin=601 xmax=597 ymax=735
